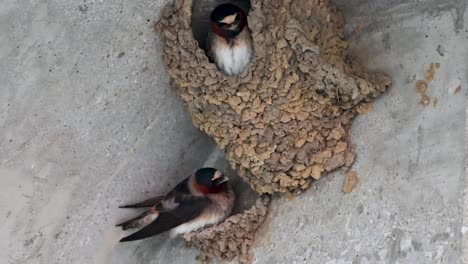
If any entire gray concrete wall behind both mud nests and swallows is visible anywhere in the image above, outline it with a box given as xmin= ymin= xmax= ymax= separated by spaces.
xmin=0 ymin=0 xmax=468 ymax=264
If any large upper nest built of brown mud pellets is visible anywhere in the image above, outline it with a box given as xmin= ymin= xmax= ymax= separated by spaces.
xmin=156 ymin=0 xmax=390 ymax=194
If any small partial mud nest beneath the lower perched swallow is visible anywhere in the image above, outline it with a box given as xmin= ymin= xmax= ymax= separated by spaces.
xmin=183 ymin=196 xmax=270 ymax=263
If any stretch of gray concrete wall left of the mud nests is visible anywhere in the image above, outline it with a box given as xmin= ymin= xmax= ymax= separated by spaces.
xmin=0 ymin=0 xmax=214 ymax=263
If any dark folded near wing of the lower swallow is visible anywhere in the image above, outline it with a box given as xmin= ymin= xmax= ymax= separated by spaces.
xmin=120 ymin=197 xmax=210 ymax=242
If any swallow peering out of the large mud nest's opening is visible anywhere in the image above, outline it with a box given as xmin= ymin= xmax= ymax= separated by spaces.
xmin=206 ymin=3 xmax=254 ymax=75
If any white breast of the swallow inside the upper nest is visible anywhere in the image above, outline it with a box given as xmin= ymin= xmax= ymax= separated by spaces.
xmin=214 ymin=40 xmax=252 ymax=75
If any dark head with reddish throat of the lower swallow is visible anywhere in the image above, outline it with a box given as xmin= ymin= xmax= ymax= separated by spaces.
xmin=195 ymin=168 xmax=229 ymax=194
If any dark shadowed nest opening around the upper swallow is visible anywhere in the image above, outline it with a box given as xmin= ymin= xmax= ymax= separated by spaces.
xmin=191 ymin=0 xmax=250 ymax=52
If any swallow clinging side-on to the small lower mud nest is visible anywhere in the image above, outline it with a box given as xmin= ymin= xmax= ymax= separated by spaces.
xmin=117 ymin=168 xmax=235 ymax=242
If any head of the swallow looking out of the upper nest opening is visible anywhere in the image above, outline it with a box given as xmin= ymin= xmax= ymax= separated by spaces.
xmin=210 ymin=3 xmax=247 ymax=37
